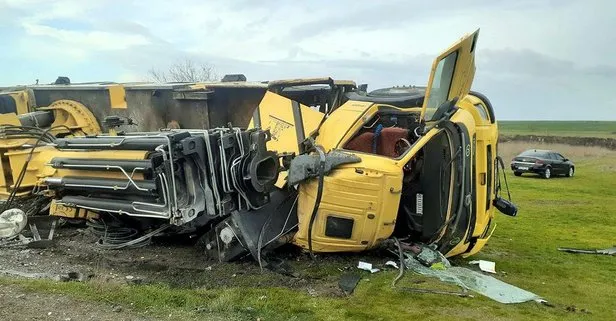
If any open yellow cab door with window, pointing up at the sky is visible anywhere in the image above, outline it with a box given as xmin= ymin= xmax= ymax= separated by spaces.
xmin=421 ymin=29 xmax=479 ymax=121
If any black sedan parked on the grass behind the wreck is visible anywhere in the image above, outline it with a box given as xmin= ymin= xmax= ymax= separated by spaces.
xmin=511 ymin=149 xmax=575 ymax=178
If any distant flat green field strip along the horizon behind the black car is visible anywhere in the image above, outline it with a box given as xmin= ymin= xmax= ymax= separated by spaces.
xmin=498 ymin=121 xmax=616 ymax=138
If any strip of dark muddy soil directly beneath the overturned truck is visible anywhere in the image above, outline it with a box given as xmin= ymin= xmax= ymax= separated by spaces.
xmin=0 ymin=226 xmax=388 ymax=297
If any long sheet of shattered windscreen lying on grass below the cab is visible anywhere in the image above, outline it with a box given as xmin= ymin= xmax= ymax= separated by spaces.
xmin=404 ymin=253 xmax=544 ymax=303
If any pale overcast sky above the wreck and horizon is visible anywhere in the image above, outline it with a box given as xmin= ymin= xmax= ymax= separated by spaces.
xmin=0 ymin=0 xmax=616 ymax=120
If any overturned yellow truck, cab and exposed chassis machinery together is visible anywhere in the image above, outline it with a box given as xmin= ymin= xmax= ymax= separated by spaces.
xmin=0 ymin=32 xmax=516 ymax=262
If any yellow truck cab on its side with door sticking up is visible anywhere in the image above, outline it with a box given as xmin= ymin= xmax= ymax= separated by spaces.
xmin=250 ymin=30 xmax=516 ymax=256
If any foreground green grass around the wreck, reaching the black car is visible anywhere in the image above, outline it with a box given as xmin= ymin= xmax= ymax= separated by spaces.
xmin=0 ymin=143 xmax=616 ymax=320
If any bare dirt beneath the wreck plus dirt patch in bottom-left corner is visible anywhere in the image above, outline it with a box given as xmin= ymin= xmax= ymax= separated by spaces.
xmin=0 ymin=226 xmax=389 ymax=320
